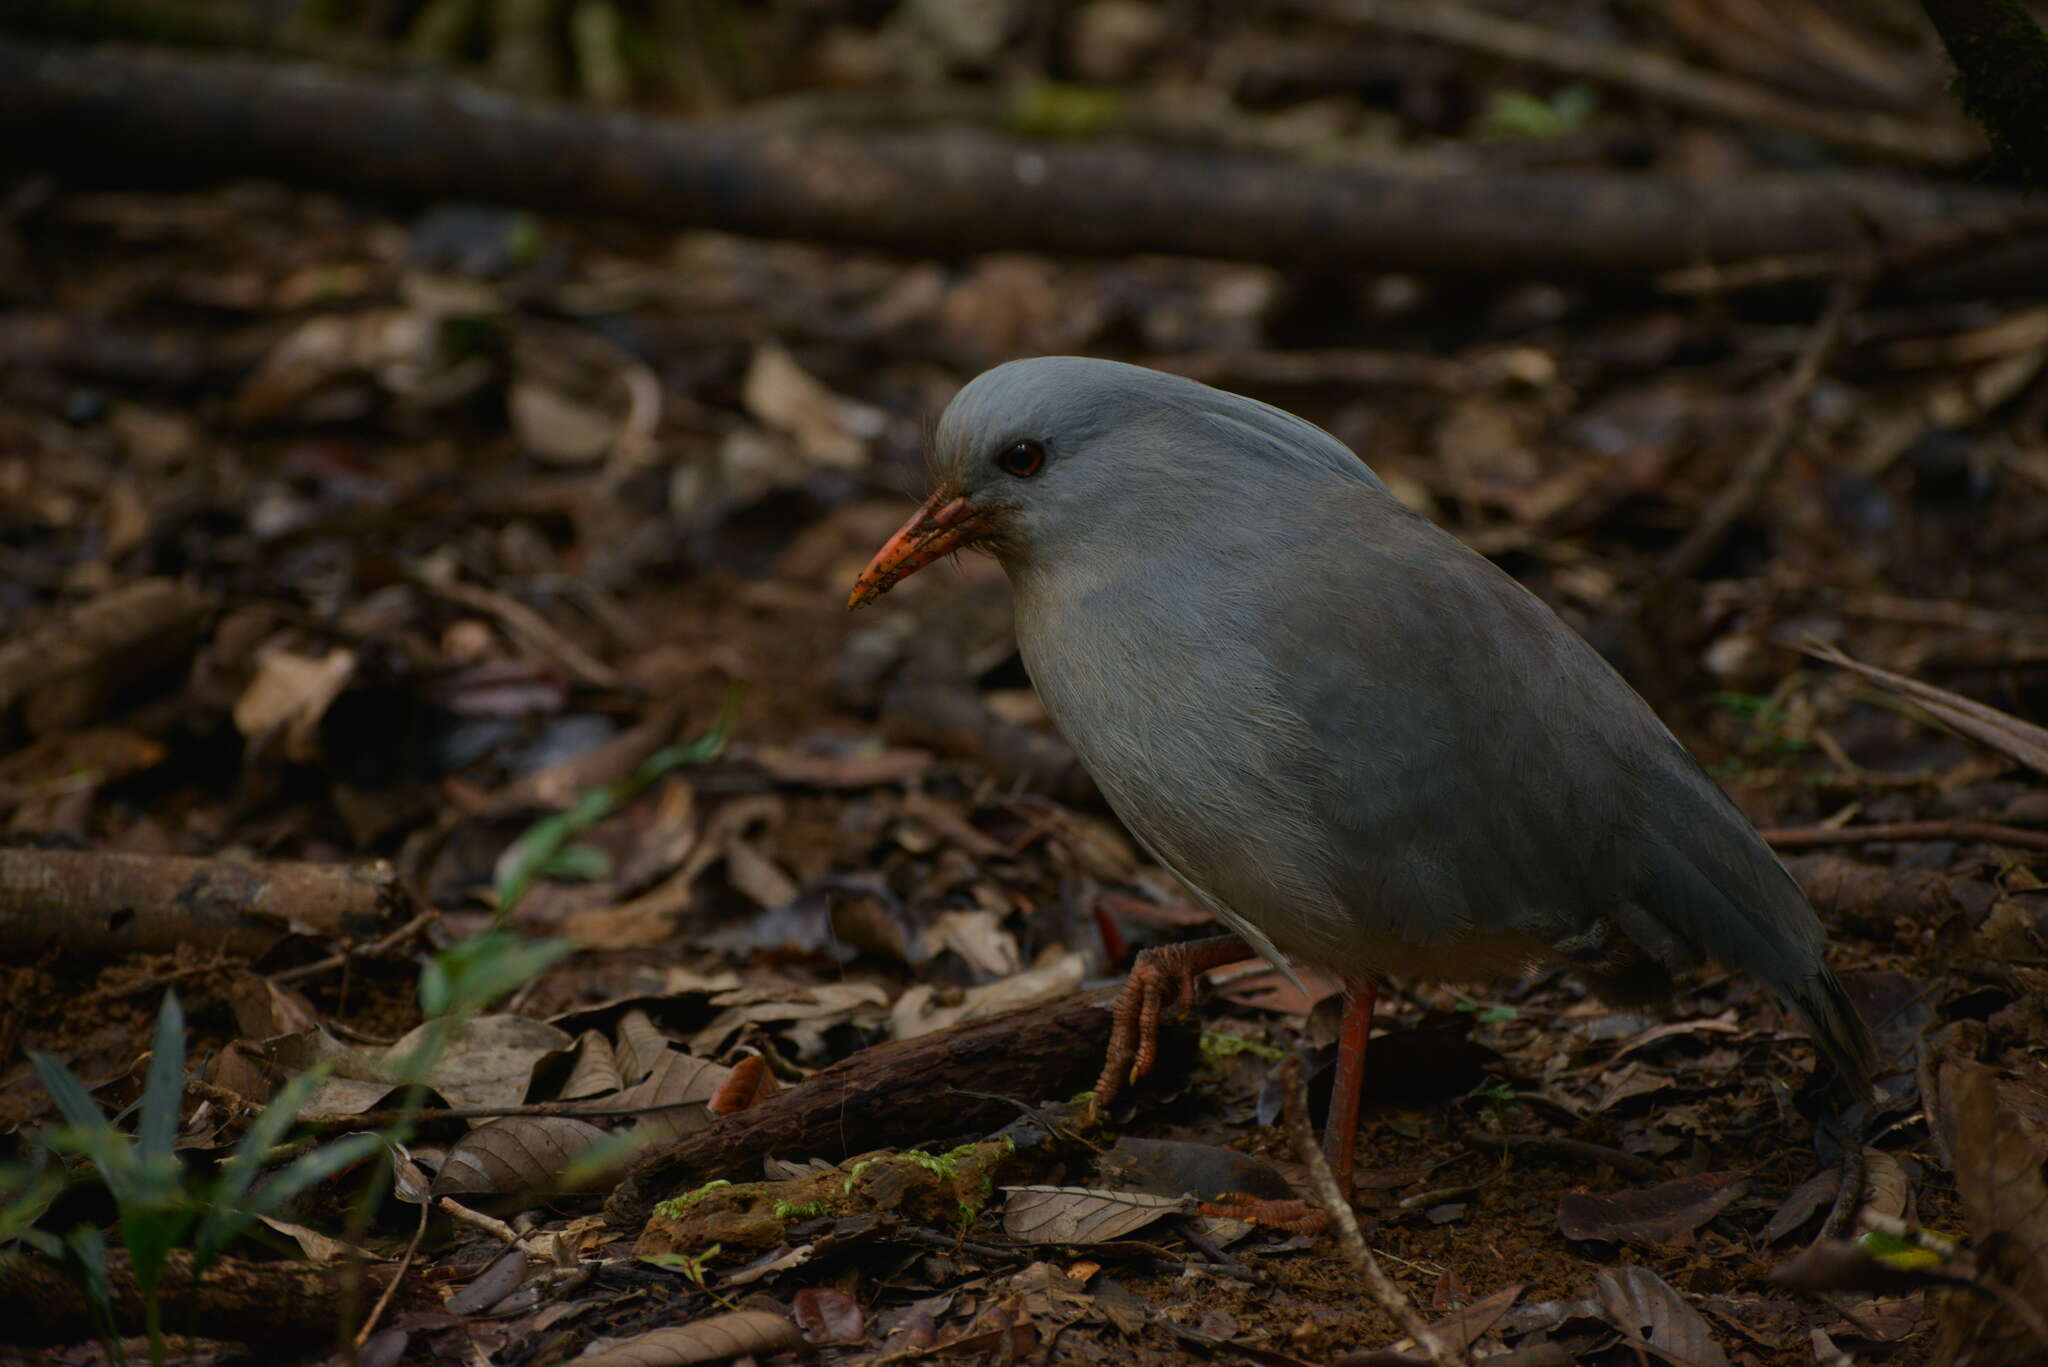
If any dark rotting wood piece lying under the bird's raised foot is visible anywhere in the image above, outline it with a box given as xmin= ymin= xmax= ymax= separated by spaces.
xmin=606 ymin=988 xmax=1188 ymax=1226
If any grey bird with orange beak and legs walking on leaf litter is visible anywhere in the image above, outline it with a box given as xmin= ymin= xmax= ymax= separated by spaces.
xmin=850 ymin=357 xmax=1874 ymax=1170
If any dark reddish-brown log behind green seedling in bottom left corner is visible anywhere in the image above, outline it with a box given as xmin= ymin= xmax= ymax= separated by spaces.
xmin=0 ymin=1248 xmax=438 ymax=1344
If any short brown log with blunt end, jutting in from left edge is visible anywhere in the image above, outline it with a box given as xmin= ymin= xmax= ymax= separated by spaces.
xmin=0 ymin=848 xmax=403 ymax=959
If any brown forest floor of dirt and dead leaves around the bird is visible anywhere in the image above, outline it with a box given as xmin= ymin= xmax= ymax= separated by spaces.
xmin=0 ymin=6 xmax=2048 ymax=1367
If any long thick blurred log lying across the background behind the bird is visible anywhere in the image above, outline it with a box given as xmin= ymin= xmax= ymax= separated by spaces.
xmin=0 ymin=41 xmax=2021 ymax=277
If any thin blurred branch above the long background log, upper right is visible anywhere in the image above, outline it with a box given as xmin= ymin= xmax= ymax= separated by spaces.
xmin=1296 ymin=0 xmax=1985 ymax=166
